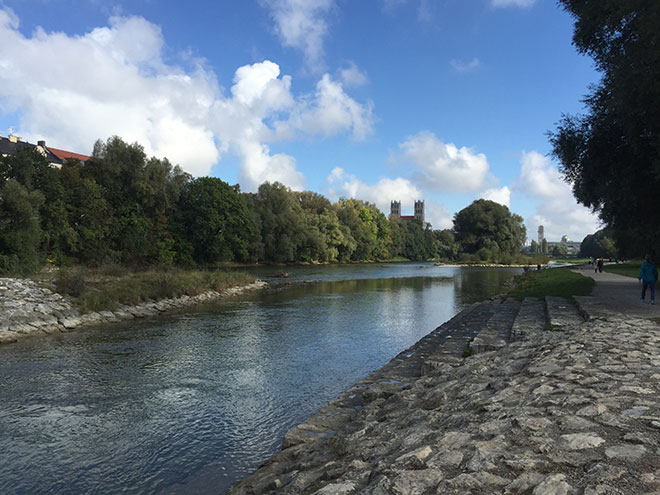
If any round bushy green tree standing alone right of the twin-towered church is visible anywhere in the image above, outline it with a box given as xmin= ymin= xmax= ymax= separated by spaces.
xmin=454 ymin=199 xmax=527 ymax=259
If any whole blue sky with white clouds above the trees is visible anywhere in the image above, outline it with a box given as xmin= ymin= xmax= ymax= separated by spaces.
xmin=0 ymin=0 xmax=600 ymax=241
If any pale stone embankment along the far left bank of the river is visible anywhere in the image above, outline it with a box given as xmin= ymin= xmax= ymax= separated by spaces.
xmin=0 ymin=278 xmax=268 ymax=344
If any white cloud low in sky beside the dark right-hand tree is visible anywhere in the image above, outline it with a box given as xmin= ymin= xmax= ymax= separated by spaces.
xmin=515 ymin=151 xmax=600 ymax=241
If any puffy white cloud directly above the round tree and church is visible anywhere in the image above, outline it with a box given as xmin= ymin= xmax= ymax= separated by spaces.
xmin=399 ymin=132 xmax=489 ymax=192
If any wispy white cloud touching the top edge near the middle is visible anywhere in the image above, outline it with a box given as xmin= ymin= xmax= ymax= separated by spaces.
xmin=262 ymin=0 xmax=335 ymax=69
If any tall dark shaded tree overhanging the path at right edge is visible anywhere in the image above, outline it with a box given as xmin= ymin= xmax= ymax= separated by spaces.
xmin=550 ymin=0 xmax=660 ymax=255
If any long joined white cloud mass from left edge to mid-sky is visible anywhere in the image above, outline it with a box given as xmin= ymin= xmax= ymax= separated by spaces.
xmin=0 ymin=8 xmax=373 ymax=190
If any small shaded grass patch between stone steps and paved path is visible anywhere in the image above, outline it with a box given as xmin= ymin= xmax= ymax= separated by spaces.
xmin=507 ymin=267 xmax=595 ymax=301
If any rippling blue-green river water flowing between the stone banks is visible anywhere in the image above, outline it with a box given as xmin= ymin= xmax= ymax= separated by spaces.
xmin=0 ymin=263 xmax=520 ymax=494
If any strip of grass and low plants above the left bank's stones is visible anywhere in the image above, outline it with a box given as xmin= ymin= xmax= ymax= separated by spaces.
xmin=35 ymin=265 xmax=255 ymax=312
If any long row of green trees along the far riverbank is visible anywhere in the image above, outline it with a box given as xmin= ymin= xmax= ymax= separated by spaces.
xmin=0 ymin=137 xmax=526 ymax=273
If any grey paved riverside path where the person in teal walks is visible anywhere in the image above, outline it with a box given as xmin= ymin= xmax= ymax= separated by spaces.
xmin=573 ymin=266 xmax=660 ymax=318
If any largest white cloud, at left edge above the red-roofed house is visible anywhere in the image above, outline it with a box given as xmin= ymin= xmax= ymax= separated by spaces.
xmin=0 ymin=10 xmax=219 ymax=174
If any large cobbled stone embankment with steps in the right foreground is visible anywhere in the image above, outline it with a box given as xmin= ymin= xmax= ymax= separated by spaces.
xmin=230 ymin=297 xmax=660 ymax=495
